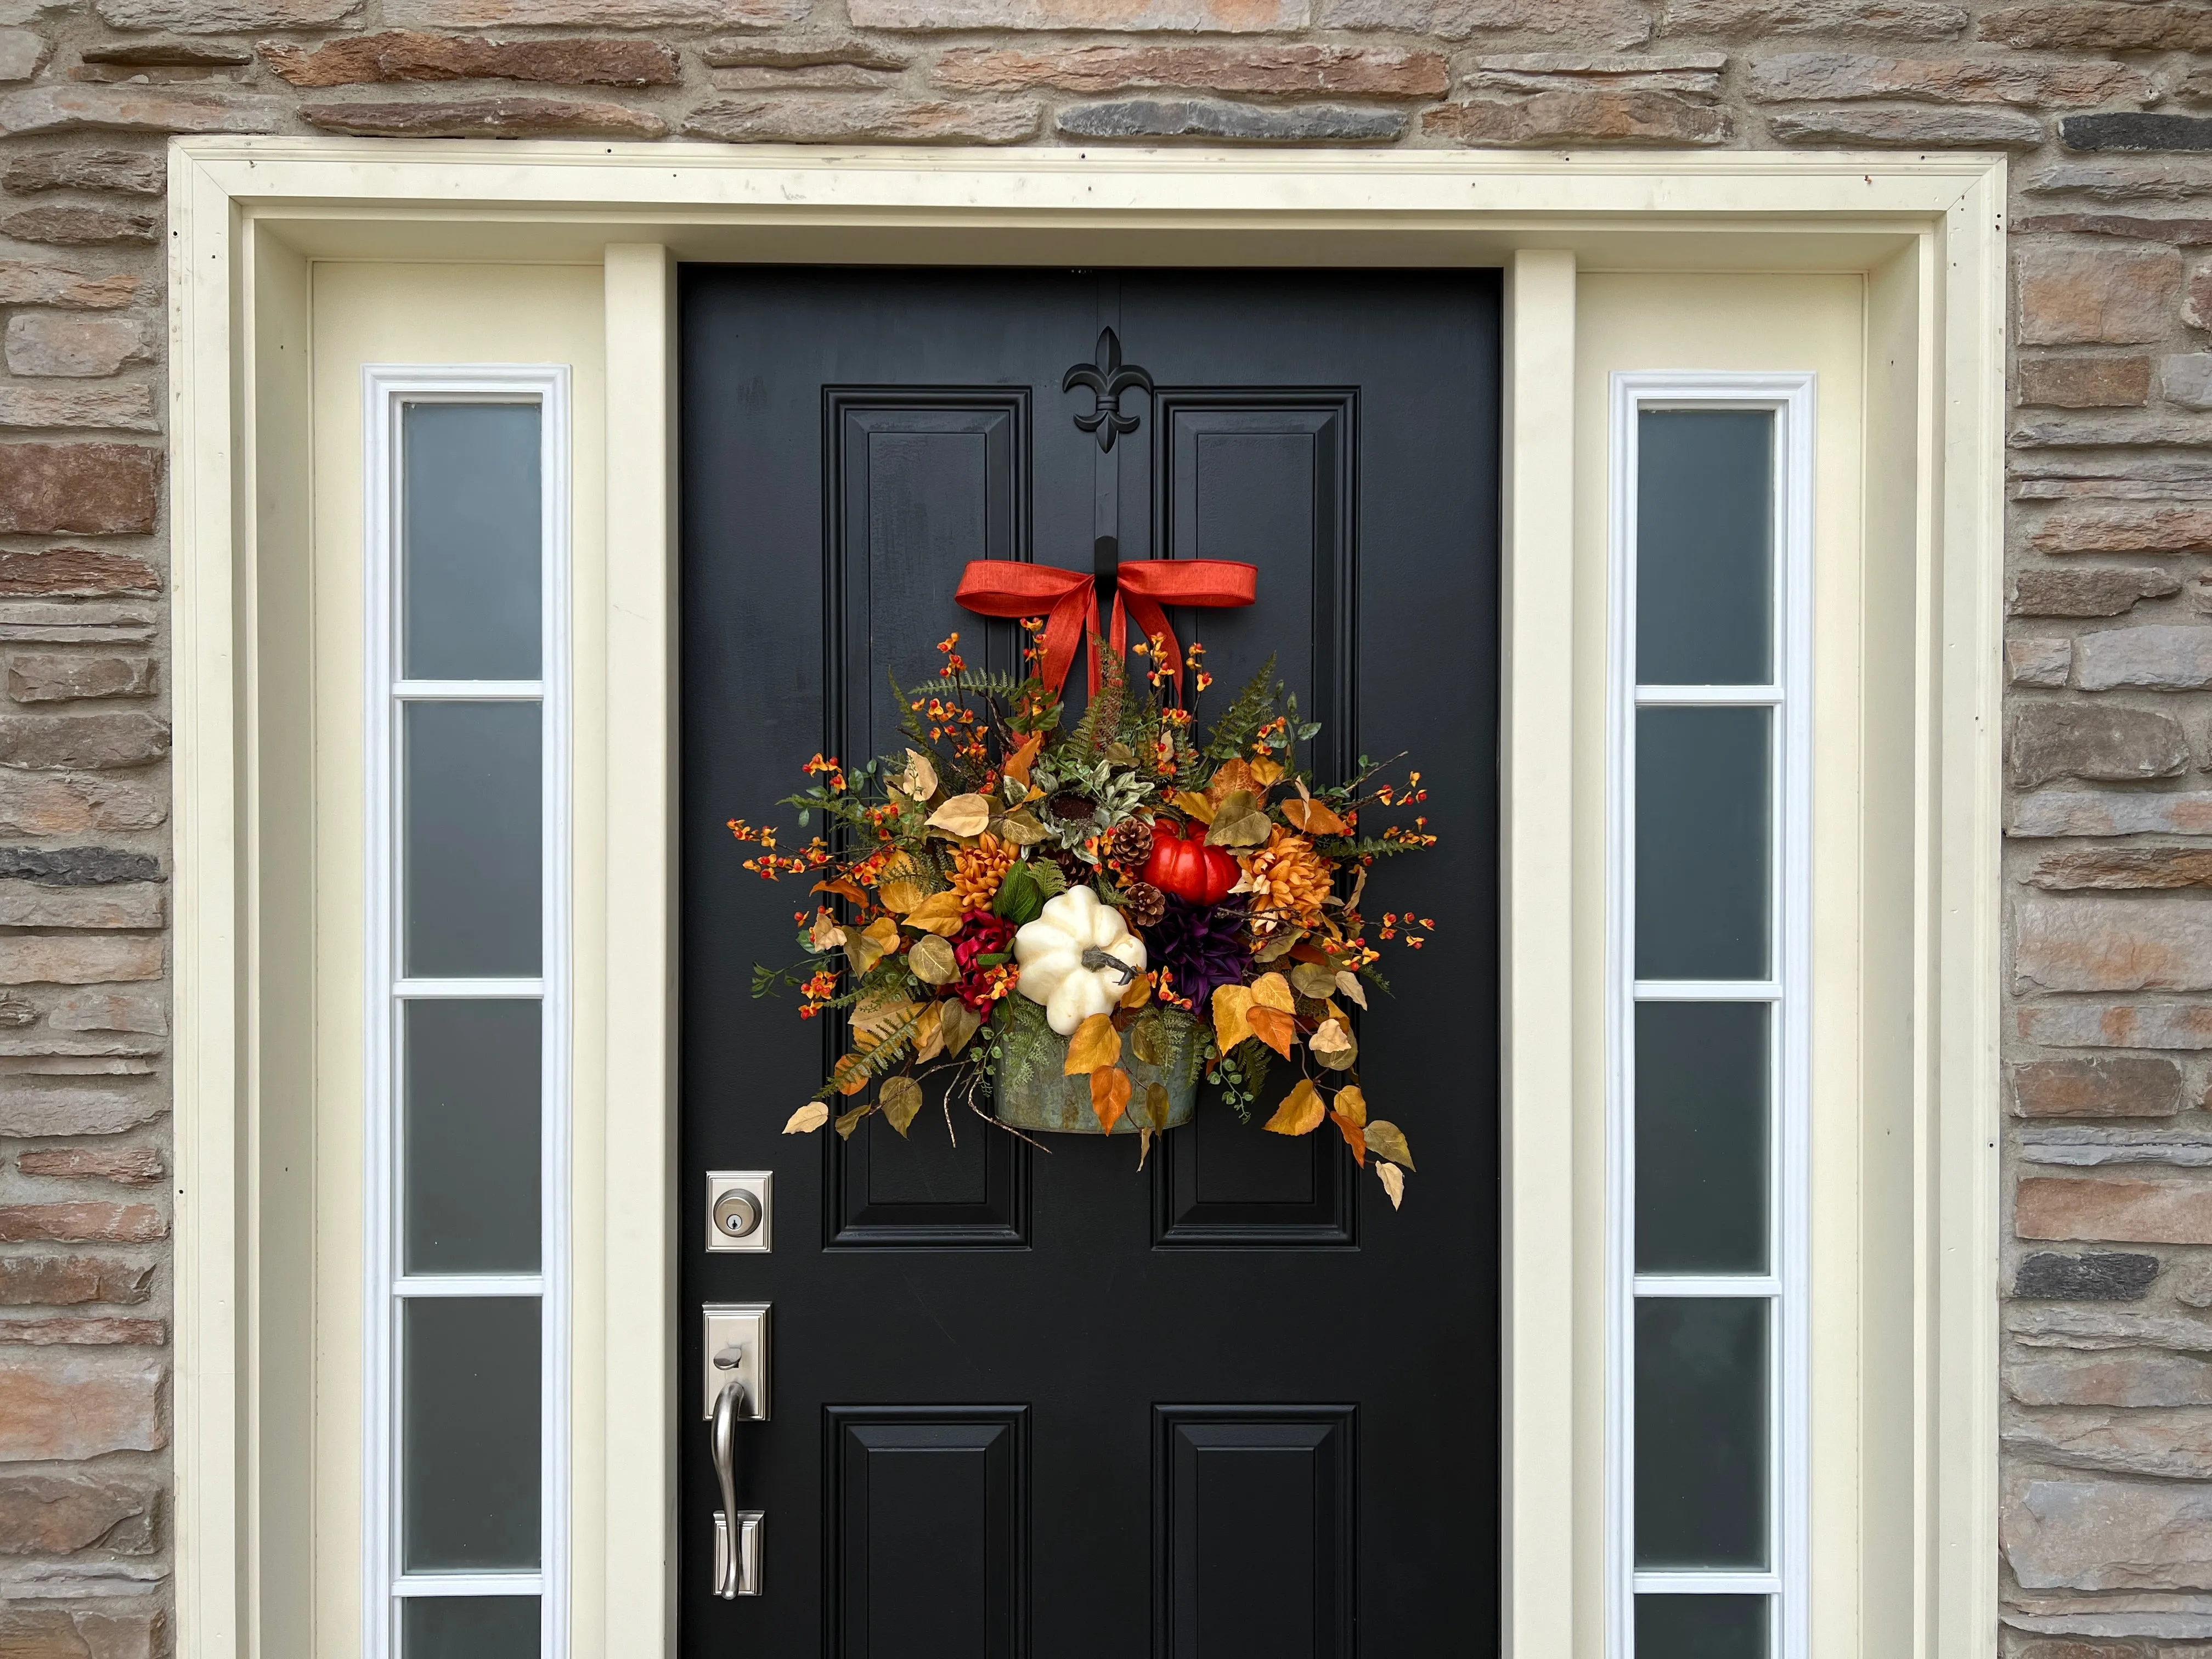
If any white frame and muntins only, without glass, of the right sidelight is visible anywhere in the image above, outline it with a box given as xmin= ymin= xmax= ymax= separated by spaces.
xmin=1606 ymin=369 xmax=1816 ymax=1659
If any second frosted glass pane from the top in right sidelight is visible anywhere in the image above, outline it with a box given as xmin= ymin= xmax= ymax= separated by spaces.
xmin=1637 ymin=708 xmax=1772 ymax=980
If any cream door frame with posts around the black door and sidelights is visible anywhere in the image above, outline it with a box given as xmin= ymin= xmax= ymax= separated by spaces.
xmin=168 ymin=137 xmax=2004 ymax=1659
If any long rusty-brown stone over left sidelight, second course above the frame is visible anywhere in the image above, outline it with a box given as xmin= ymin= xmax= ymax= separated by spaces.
xmin=261 ymin=29 xmax=684 ymax=86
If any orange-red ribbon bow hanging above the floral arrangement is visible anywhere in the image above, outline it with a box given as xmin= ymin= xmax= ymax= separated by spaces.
xmin=953 ymin=560 xmax=1259 ymax=697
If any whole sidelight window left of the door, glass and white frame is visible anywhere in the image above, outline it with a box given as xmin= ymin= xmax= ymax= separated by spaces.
xmin=363 ymin=367 xmax=568 ymax=1659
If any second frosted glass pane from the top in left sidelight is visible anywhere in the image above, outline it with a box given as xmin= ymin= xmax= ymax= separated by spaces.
xmin=400 ymin=703 xmax=544 ymax=978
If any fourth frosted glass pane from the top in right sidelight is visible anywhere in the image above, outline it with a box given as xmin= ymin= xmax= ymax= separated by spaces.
xmin=1637 ymin=1296 xmax=1768 ymax=1571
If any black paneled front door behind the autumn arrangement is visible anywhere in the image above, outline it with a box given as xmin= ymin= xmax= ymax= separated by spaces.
xmin=677 ymin=268 xmax=1500 ymax=1659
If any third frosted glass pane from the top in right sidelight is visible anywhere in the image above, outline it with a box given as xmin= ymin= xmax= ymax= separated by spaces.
xmin=1637 ymin=1002 xmax=1772 ymax=1274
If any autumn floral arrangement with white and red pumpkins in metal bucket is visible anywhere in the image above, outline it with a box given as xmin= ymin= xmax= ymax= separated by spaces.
xmin=730 ymin=619 xmax=1436 ymax=1205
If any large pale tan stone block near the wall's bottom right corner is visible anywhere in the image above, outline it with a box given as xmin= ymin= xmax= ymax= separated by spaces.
xmin=2002 ymin=1480 xmax=2212 ymax=1590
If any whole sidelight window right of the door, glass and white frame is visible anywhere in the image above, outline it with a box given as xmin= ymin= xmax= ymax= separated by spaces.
xmin=1608 ymin=374 xmax=1812 ymax=1659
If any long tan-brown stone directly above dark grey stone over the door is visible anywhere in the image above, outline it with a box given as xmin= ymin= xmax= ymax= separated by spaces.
xmin=931 ymin=44 xmax=1451 ymax=97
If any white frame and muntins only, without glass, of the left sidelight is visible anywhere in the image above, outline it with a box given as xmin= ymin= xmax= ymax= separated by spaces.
xmin=360 ymin=363 xmax=573 ymax=1659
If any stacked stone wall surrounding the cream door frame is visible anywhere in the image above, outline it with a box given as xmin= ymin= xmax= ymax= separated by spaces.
xmin=0 ymin=0 xmax=2212 ymax=1659
